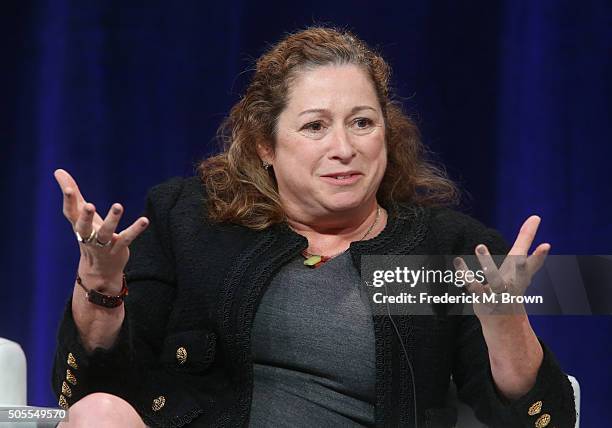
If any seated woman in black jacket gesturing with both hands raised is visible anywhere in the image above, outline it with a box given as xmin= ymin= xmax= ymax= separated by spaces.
xmin=53 ymin=28 xmax=575 ymax=427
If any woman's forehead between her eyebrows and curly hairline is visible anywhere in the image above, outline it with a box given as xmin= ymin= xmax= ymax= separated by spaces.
xmin=287 ymin=64 xmax=378 ymax=113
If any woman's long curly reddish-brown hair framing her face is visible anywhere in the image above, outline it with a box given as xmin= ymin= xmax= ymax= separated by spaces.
xmin=198 ymin=27 xmax=459 ymax=230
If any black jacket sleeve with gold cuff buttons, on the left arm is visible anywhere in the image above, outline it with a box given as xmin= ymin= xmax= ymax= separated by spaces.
xmin=52 ymin=179 xmax=215 ymax=426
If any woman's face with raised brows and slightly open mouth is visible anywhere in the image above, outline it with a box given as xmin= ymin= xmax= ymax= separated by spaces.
xmin=267 ymin=65 xmax=387 ymax=218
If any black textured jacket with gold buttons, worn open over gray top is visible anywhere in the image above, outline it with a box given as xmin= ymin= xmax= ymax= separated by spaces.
xmin=53 ymin=177 xmax=575 ymax=428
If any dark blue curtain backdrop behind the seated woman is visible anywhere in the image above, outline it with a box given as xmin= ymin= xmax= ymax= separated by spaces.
xmin=0 ymin=0 xmax=612 ymax=426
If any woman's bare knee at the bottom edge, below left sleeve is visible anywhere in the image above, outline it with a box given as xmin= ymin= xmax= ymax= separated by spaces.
xmin=59 ymin=392 xmax=145 ymax=428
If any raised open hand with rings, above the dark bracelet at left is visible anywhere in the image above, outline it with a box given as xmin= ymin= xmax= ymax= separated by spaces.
xmin=54 ymin=169 xmax=149 ymax=294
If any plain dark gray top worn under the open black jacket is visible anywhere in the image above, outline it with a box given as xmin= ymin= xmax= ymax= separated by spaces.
xmin=250 ymin=252 xmax=376 ymax=427
